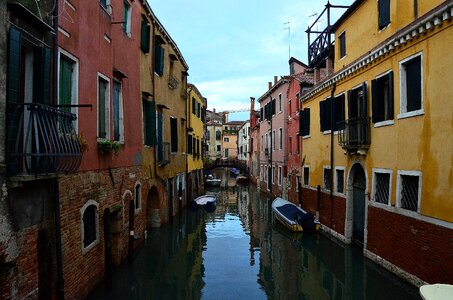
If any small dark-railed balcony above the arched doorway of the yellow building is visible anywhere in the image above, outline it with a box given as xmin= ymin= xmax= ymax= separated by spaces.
xmin=338 ymin=117 xmax=371 ymax=153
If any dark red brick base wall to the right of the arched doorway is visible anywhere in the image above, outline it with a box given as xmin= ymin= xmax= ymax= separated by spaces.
xmin=367 ymin=206 xmax=453 ymax=284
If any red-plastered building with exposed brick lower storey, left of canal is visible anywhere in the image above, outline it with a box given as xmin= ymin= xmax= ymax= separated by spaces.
xmin=58 ymin=0 xmax=149 ymax=298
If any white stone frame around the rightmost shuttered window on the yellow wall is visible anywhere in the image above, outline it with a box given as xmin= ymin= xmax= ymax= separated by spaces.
xmin=397 ymin=52 xmax=425 ymax=119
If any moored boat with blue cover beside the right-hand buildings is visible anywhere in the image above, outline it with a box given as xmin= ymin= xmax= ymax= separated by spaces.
xmin=272 ymin=197 xmax=321 ymax=233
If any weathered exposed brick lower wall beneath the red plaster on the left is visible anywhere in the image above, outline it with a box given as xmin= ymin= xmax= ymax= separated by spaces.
xmin=59 ymin=167 xmax=150 ymax=298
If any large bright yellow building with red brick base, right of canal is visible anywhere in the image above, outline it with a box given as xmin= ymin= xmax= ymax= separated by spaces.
xmin=301 ymin=0 xmax=453 ymax=285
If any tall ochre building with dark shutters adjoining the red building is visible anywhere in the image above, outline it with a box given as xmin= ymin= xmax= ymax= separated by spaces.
xmin=139 ymin=2 xmax=188 ymax=227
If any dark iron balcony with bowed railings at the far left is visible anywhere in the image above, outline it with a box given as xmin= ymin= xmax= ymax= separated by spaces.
xmin=6 ymin=103 xmax=82 ymax=176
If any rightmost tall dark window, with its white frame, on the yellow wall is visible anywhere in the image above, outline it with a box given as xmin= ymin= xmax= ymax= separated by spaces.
xmin=398 ymin=54 xmax=423 ymax=118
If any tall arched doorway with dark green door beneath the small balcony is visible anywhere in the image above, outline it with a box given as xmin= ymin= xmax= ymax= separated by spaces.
xmin=350 ymin=164 xmax=366 ymax=247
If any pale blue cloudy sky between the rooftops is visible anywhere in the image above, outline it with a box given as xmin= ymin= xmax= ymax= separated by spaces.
xmin=148 ymin=0 xmax=353 ymax=121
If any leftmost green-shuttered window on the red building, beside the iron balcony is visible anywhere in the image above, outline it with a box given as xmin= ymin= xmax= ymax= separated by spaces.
xmin=58 ymin=50 xmax=78 ymax=130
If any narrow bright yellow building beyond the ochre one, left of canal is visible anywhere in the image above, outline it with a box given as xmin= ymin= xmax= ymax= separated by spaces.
xmin=187 ymin=83 xmax=207 ymax=201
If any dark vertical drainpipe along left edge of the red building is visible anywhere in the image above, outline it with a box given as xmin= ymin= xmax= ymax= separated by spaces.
xmin=52 ymin=1 xmax=64 ymax=299
